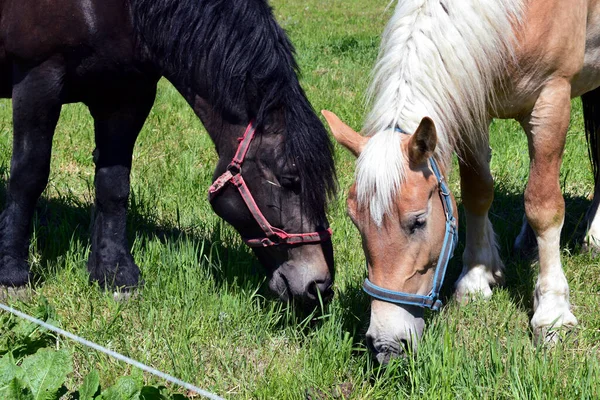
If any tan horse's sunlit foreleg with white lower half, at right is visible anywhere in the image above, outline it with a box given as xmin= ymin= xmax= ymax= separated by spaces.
xmin=521 ymin=79 xmax=577 ymax=340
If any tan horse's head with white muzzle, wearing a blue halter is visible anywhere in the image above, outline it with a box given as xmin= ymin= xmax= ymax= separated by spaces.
xmin=323 ymin=111 xmax=456 ymax=363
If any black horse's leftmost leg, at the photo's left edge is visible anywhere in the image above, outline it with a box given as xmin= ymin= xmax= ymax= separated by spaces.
xmin=0 ymin=60 xmax=64 ymax=287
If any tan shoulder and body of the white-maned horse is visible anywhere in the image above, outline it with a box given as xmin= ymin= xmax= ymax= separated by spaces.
xmin=495 ymin=0 xmax=600 ymax=118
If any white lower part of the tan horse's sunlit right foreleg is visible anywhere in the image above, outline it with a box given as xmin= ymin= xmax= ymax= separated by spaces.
xmin=531 ymin=224 xmax=577 ymax=342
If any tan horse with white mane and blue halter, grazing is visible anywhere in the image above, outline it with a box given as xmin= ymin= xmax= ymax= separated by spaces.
xmin=324 ymin=0 xmax=600 ymax=362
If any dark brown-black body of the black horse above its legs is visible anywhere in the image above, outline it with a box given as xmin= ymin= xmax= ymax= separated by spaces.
xmin=0 ymin=0 xmax=142 ymax=97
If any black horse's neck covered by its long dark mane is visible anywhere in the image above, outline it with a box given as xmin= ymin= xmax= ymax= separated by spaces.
xmin=130 ymin=0 xmax=302 ymax=154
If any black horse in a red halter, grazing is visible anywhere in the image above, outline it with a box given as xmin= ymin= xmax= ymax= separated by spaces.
xmin=0 ymin=0 xmax=335 ymax=306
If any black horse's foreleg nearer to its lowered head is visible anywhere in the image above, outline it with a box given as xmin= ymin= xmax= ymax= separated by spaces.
xmin=88 ymin=83 xmax=156 ymax=291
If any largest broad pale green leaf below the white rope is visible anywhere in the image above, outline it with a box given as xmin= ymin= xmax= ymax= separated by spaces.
xmin=21 ymin=349 xmax=73 ymax=400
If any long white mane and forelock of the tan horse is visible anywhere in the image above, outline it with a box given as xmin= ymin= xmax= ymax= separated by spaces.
xmin=356 ymin=0 xmax=524 ymax=223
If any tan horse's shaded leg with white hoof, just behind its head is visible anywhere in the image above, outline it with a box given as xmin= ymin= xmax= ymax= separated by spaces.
xmin=455 ymin=131 xmax=504 ymax=300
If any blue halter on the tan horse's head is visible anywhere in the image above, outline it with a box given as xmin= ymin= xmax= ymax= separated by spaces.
xmin=363 ymin=127 xmax=458 ymax=311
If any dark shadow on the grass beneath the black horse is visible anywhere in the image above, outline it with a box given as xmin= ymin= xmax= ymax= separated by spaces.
xmin=0 ymin=171 xmax=270 ymax=297
